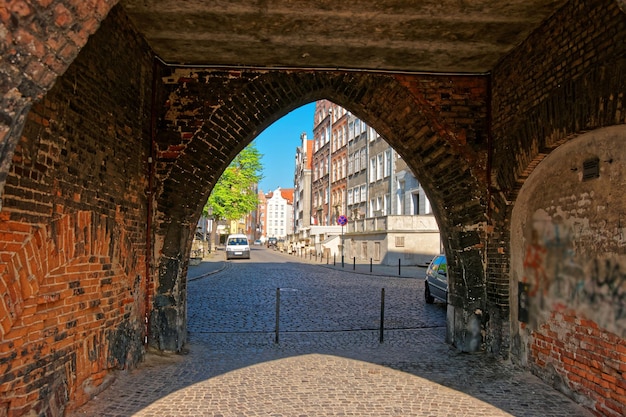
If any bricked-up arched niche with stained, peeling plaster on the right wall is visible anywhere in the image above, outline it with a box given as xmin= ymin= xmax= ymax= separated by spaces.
xmin=510 ymin=125 xmax=626 ymax=407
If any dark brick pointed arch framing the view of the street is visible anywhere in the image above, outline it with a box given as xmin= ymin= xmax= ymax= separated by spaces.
xmin=151 ymin=68 xmax=487 ymax=350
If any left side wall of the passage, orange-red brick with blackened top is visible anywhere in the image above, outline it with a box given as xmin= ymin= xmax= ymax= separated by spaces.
xmin=0 ymin=7 xmax=152 ymax=416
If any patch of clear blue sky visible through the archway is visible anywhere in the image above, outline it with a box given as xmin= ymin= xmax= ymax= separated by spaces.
xmin=254 ymin=102 xmax=315 ymax=193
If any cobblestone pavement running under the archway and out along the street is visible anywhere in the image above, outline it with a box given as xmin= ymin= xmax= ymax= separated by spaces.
xmin=70 ymin=249 xmax=591 ymax=417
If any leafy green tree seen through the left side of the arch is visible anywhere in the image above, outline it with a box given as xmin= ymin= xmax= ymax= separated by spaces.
xmin=202 ymin=143 xmax=263 ymax=220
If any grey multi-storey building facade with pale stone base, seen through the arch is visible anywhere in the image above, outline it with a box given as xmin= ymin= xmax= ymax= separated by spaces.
xmin=333 ymin=109 xmax=441 ymax=265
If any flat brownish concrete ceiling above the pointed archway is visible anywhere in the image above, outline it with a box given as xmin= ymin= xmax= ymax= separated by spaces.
xmin=120 ymin=0 xmax=567 ymax=73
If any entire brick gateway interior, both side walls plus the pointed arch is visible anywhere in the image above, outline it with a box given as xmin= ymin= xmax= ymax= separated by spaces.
xmin=0 ymin=0 xmax=626 ymax=416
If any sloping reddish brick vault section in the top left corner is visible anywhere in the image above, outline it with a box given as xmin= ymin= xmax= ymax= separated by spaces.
xmin=0 ymin=0 xmax=119 ymax=192
